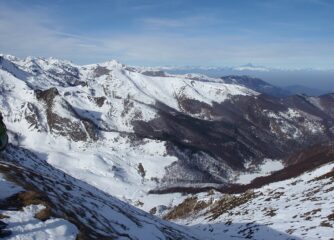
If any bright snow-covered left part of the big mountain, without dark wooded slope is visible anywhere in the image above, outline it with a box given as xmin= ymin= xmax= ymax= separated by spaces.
xmin=0 ymin=56 xmax=253 ymax=200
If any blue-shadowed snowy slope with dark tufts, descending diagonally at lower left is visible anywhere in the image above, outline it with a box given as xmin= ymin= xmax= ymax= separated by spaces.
xmin=0 ymin=146 xmax=197 ymax=240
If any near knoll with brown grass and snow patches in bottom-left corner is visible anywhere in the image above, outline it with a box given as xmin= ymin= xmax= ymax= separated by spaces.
xmin=0 ymin=166 xmax=78 ymax=240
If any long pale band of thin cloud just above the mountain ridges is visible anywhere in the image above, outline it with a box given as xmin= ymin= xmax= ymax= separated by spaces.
xmin=0 ymin=3 xmax=334 ymax=67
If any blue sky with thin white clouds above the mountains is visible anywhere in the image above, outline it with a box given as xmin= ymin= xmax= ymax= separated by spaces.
xmin=0 ymin=0 xmax=334 ymax=69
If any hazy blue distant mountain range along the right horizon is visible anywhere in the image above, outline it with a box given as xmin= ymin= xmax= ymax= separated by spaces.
xmin=155 ymin=64 xmax=334 ymax=96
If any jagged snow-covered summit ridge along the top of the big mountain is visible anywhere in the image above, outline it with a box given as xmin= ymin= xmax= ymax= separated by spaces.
xmin=0 ymin=54 xmax=257 ymax=107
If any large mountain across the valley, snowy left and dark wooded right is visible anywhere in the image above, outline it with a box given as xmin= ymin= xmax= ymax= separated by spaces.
xmin=0 ymin=53 xmax=334 ymax=192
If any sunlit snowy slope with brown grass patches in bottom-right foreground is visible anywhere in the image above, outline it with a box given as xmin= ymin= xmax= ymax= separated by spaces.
xmin=170 ymin=155 xmax=334 ymax=240
